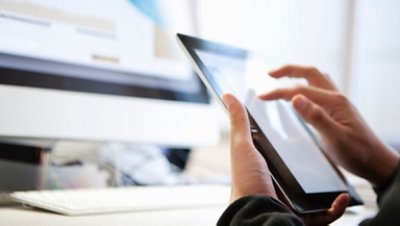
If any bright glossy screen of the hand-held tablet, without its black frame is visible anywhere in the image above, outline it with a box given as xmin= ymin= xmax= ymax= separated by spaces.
xmin=194 ymin=49 xmax=347 ymax=193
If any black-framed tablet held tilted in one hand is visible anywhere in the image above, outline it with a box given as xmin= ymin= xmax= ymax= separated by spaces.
xmin=177 ymin=34 xmax=362 ymax=213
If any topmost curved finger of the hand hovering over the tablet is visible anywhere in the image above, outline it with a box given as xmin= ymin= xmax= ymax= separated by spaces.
xmin=269 ymin=65 xmax=337 ymax=90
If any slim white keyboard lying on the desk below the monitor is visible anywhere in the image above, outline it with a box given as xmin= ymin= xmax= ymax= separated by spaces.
xmin=10 ymin=185 xmax=230 ymax=216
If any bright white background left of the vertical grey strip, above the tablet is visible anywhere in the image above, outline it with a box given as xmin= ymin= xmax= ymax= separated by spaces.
xmin=198 ymin=0 xmax=348 ymax=89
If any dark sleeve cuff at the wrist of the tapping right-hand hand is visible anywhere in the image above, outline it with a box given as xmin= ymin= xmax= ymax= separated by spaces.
xmin=360 ymin=164 xmax=400 ymax=226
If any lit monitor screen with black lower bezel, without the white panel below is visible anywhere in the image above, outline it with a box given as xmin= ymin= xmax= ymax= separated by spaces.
xmin=0 ymin=0 xmax=207 ymax=102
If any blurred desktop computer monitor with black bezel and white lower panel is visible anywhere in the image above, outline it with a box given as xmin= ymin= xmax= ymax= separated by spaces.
xmin=0 ymin=0 xmax=219 ymax=147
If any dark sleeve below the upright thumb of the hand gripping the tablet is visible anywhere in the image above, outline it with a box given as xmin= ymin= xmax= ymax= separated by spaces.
xmin=217 ymin=196 xmax=303 ymax=226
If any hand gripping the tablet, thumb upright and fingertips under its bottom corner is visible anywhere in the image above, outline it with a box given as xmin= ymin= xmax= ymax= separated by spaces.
xmin=223 ymin=94 xmax=349 ymax=225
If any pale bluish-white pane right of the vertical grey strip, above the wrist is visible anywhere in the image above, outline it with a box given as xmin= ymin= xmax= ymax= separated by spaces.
xmin=352 ymin=0 xmax=400 ymax=144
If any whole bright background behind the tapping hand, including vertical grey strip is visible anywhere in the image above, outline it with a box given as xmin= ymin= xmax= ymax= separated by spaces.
xmin=193 ymin=0 xmax=400 ymax=148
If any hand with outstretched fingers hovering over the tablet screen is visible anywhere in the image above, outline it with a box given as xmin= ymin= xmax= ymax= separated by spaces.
xmin=260 ymin=65 xmax=399 ymax=187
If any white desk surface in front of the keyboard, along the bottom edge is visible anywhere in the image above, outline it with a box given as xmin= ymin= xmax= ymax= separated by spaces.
xmin=0 ymin=206 xmax=225 ymax=226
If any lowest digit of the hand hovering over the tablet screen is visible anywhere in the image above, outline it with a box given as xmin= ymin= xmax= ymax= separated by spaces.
xmin=292 ymin=94 xmax=336 ymax=135
